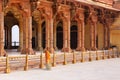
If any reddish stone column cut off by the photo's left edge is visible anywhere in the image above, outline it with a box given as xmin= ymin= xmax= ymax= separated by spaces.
xmin=0 ymin=12 xmax=6 ymax=56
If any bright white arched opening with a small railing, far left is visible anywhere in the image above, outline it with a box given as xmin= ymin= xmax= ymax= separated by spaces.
xmin=11 ymin=25 xmax=19 ymax=49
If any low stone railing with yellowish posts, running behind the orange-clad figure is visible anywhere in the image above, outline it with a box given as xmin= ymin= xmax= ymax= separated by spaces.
xmin=0 ymin=49 xmax=120 ymax=73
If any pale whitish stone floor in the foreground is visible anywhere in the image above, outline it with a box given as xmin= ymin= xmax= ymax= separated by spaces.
xmin=0 ymin=58 xmax=120 ymax=80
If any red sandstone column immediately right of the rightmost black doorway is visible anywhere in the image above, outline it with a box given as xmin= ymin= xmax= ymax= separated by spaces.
xmin=75 ymin=8 xmax=85 ymax=51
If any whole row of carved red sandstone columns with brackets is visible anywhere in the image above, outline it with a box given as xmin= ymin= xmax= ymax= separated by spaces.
xmin=0 ymin=0 xmax=113 ymax=56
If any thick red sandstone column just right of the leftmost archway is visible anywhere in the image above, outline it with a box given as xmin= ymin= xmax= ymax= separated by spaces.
xmin=22 ymin=16 xmax=35 ymax=54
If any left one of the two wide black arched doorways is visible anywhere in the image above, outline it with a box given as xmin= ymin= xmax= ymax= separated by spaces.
xmin=56 ymin=22 xmax=63 ymax=49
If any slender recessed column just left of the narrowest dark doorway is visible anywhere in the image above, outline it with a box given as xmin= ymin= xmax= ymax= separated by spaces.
xmin=37 ymin=20 xmax=43 ymax=51
